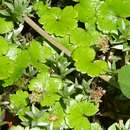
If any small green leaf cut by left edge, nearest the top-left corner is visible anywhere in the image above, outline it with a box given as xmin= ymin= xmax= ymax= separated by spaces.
xmin=0 ymin=17 xmax=14 ymax=34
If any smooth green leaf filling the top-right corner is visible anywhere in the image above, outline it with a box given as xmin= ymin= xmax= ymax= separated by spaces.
xmin=106 ymin=0 xmax=130 ymax=17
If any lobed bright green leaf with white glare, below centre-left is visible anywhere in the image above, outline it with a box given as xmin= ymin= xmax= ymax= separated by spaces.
xmin=28 ymin=72 xmax=62 ymax=106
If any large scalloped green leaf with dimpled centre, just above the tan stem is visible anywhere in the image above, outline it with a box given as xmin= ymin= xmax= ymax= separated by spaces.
xmin=39 ymin=6 xmax=77 ymax=36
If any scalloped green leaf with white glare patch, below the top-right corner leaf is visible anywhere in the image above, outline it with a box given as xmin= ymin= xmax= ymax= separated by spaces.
xmin=97 ymin=2 xmax=118 ymax=34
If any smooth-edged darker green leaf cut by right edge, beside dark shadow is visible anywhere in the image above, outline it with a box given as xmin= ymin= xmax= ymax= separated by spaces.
xmin=118 ymin=65 xmax=130 ymax=98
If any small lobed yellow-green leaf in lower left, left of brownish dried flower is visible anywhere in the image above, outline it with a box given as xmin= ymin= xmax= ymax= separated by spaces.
xmin=10 ymin=90 xmax=28 ymax=112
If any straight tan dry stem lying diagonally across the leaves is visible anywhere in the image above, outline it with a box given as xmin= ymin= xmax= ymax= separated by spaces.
xmin=24 ymin=16 xmax=71 ymax=57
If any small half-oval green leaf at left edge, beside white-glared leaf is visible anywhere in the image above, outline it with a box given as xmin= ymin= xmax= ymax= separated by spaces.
xmin=0 ymin=37 xmax=9 ymax=55
